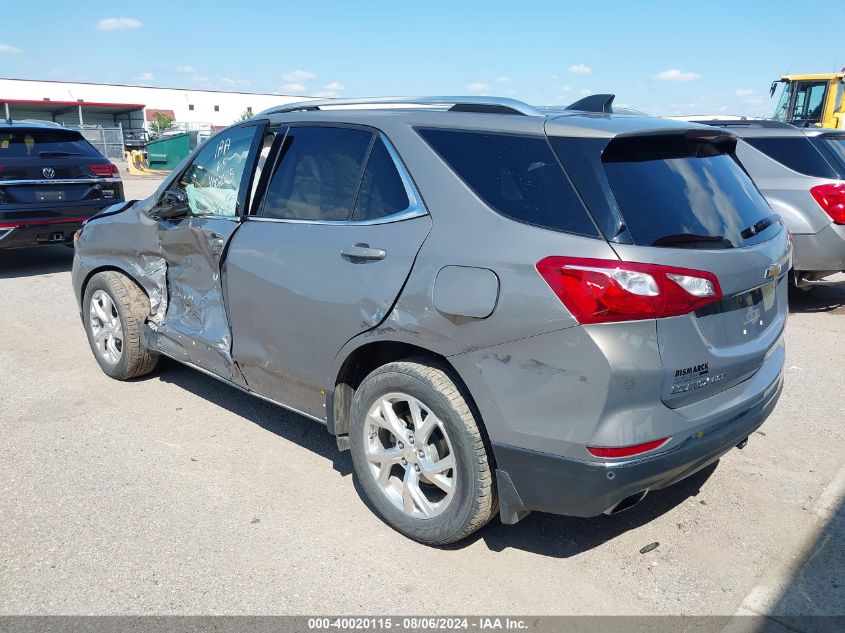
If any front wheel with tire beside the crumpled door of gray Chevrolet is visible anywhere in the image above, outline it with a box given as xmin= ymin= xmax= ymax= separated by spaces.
xmin=83 ymin=271 xmax=158 ymax=380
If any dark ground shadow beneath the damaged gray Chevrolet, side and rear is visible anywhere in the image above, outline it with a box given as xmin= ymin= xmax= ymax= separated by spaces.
xmin=154 ymin=359 xmax=718 ymax=558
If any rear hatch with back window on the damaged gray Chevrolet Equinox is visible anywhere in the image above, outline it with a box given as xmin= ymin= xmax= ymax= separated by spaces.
xmin=551 ymin=128 xmax=791 ymax=408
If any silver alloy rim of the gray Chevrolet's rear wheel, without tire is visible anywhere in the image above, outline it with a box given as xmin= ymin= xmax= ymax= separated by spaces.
xmin=364 ymin=393 xmax=457 ymax=519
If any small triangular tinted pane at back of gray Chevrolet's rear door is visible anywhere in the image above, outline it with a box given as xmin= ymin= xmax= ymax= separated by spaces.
xmin=352 ymin=138 xmax=410 ymax=221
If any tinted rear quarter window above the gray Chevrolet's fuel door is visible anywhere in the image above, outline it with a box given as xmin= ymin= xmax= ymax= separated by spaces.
xmin=419 ymin=129 xmax=598 ymax=237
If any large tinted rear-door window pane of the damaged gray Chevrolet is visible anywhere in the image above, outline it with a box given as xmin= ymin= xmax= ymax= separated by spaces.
xmin=261 ymin=127 xmax=373 ymax=220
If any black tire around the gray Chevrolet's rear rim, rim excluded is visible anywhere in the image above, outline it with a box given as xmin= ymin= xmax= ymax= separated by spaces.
xmin=349 ymin=358 xmax=497 ymax=545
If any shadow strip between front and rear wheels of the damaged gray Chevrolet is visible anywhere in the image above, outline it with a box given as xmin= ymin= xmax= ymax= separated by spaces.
xmin=152 ymin=358 xmax=352 ymax=476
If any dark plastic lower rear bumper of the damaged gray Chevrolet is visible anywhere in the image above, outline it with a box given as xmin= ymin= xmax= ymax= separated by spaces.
xmin=493 ymin=362 xmax=783 ymax=523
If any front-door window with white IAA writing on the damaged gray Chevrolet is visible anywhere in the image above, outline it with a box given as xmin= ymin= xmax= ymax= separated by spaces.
xmin=176 ymin=126 xmax=258 ymax=217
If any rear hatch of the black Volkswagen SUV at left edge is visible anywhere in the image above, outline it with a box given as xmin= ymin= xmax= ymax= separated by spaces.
xmin=0 ymin=126 xmax=123 ymax=210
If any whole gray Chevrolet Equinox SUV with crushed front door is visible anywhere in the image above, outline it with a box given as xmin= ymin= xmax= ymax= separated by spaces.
xmin=73 ymin=95 xmax=791 ymax=544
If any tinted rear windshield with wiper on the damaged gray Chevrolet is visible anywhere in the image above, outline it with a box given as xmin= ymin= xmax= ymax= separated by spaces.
xmin=602 ymin=137 xmax=779 ymax=249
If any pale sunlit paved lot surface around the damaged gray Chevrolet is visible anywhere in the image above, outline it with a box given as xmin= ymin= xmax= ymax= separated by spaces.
xmin=0 ymin=174 xmax=845 ymax=615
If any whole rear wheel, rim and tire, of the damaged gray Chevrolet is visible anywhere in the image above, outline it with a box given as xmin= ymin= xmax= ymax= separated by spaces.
xmin=349 ymin=359 xmax=496 ymax=545
